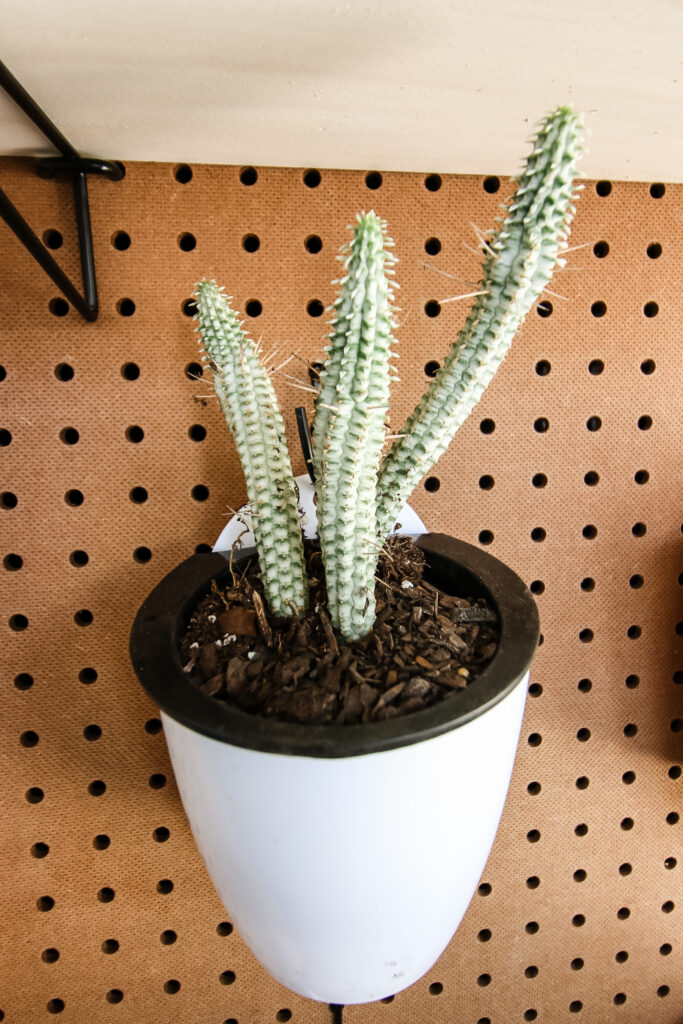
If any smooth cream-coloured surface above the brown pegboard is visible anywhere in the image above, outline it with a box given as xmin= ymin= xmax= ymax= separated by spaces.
xmin=0 ymin=0 xmax=683 ymax=181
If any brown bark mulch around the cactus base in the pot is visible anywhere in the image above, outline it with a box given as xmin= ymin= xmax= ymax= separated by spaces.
xmin=180 ymin=537 xmax=499 ymax=725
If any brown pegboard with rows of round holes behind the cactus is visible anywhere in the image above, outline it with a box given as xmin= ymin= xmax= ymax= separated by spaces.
xmin=0 ymin=153 xmax=683 ymax=1024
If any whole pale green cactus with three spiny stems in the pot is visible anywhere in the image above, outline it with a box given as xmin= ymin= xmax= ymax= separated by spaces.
xmin=191 ymin=108 xmax=581 ymax=641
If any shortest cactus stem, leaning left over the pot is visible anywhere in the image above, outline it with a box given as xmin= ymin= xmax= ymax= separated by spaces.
xmin=197 ymin=281 xmax=308 ymax=615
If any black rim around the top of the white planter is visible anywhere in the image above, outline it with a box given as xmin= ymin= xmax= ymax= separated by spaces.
xmin=130 ymin=534 xmax=539 ymax=758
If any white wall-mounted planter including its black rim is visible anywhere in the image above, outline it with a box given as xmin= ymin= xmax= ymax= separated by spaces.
xmin=131 ymin=535 xmax=539 ymax=1004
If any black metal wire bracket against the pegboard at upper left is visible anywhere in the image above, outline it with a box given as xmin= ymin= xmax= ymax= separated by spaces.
xmin=0 ymin=60 xmax=125 ymax=323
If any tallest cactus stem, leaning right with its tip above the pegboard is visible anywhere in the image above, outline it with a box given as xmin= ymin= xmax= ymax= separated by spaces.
xmin=377 ymin=108 xmax=581 ymax=541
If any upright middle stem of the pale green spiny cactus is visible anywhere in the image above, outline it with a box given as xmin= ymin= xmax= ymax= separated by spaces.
xmin=313 ymin=212 xmax=395 ymax=641
